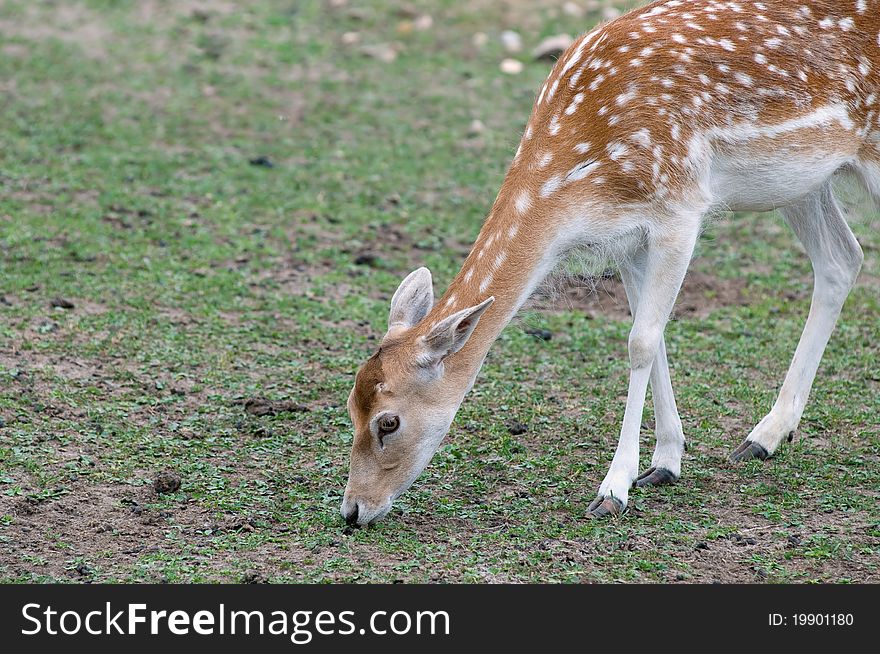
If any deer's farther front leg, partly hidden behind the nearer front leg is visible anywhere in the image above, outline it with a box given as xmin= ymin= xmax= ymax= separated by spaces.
xmin=620 ymin=249 xmax=685 ymax=487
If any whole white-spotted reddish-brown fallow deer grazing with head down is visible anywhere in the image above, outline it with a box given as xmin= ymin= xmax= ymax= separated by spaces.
xmin=341 ymin=0 xmax=880 ymax=525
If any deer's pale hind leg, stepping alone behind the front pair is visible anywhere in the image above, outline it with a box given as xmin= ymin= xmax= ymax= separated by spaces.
xmin=730 ymin=182 xmax=863 ymax=461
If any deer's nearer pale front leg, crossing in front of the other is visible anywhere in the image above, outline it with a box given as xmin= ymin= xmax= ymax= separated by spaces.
xmin=589 ymin=214 xmax=701 ymax=517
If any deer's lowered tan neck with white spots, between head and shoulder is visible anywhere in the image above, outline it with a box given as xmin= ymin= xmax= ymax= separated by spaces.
xmin=422 ymin=189 xmax=558 ymax=390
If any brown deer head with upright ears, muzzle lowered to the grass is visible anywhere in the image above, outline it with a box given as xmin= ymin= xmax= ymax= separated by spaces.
xmin=341 ymin=268 xmax=495 ymax=525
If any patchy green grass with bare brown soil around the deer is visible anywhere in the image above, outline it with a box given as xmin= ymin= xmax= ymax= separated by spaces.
xmin=0 ymin=0 xmax=880 ymax=582
